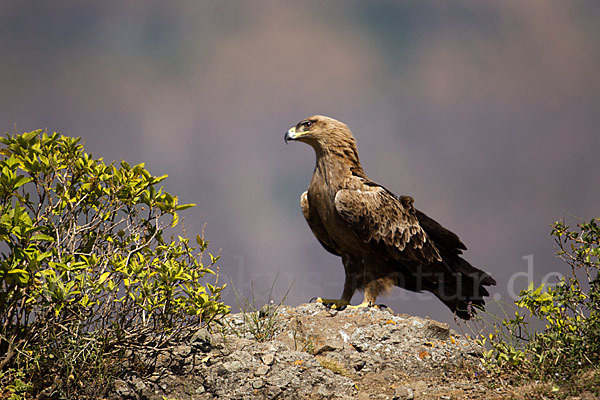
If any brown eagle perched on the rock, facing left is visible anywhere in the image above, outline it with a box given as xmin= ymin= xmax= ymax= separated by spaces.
xmin=284 ymin=115 xmax=496 ymax=319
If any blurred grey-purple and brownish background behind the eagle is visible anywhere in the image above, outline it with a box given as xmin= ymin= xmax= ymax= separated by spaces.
xmin=0 ymin=0 xmax=600 ymax=322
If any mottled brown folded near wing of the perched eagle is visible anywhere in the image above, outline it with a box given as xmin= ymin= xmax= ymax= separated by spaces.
xmin=335 ymin=182 xmax=442 ymax=264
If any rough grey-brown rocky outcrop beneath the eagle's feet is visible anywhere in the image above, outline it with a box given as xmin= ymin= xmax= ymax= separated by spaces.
xmin=112 ymin=304 xmax=488 ymax=400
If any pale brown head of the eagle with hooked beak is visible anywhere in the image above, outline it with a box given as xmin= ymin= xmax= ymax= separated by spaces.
xmin=283 ymin=115 xmax=355 ymax=150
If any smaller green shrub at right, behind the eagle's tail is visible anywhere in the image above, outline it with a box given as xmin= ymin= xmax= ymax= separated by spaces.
xmin=481 ymin=218 xmax=600 ymax=390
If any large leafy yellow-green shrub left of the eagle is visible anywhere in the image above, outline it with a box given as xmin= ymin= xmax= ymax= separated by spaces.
xmin=0 ymin=131 xmax=229 ymax=398
